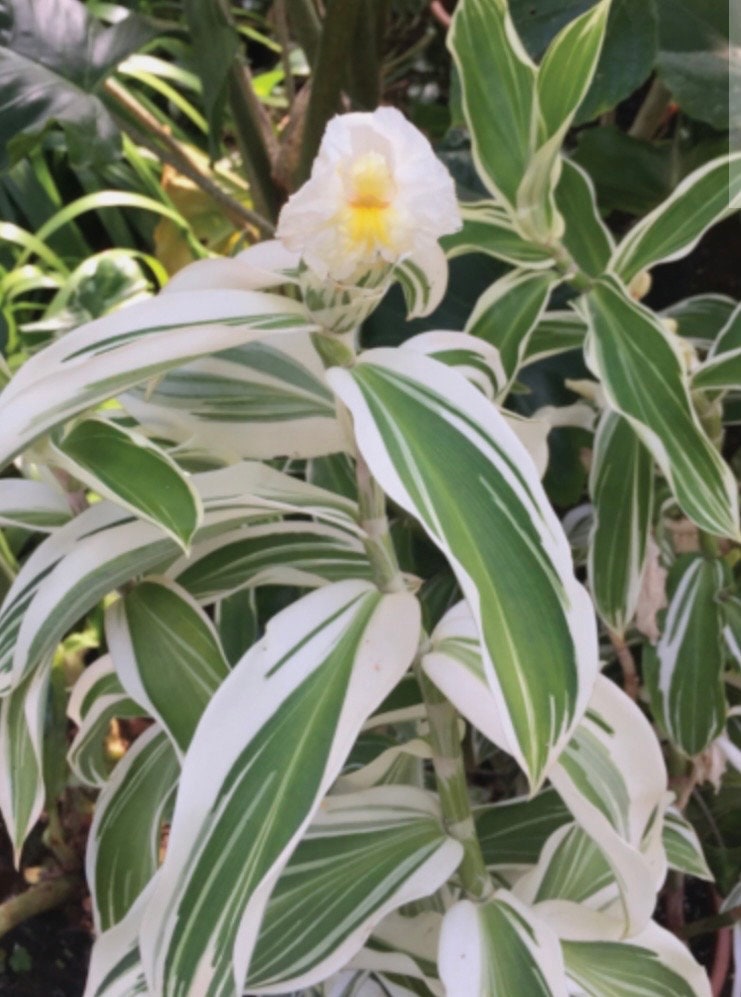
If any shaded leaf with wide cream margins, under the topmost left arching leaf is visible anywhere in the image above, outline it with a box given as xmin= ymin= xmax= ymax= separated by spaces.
xmin=120 ymin=332 xmax=344 ymax=460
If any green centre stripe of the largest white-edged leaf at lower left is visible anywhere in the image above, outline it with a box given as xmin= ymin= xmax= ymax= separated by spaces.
xmin=151 ymin=592 xmax=380 ymax=997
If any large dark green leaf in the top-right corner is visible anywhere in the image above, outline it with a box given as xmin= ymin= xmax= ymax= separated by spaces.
xmin=657 ymin=0 xmax=741 ymax=131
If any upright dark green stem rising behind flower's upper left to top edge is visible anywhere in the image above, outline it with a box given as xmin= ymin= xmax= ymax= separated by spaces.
xmin=297 ymin=0 xmax=361 ymax=186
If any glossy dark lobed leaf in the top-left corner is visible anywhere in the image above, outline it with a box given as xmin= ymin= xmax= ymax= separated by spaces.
xmin=0 ymin=0 xmax=155 ymax=168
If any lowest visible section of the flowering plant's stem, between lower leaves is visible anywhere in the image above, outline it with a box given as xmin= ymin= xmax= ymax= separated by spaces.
xmin=416 ymin=666 xmax=494 ymax=900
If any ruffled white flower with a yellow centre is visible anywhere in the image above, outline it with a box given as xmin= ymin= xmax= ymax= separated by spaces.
xmin=277 ymin=107 xmax=461 ymax=282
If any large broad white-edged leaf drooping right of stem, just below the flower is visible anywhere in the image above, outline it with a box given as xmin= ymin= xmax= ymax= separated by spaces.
xmin=328 ymin=350 xmax=598 ymax=788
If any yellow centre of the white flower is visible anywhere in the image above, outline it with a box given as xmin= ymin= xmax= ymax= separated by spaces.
xmin=344 ymin=152 xmax=395 ymax=251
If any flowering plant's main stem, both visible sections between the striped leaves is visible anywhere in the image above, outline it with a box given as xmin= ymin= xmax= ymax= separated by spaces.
xmin=356 ymin=456 xmax=494 ymax=900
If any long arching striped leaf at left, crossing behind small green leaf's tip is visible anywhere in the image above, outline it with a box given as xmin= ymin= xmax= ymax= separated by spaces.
xmin=0 ymin=462 xmax=359 ymax=694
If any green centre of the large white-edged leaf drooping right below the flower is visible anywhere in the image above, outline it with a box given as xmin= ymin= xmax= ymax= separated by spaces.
xmin=353 ymin=364 xmax=578 ymax=784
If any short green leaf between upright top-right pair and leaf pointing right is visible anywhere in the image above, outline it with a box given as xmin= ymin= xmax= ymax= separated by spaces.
xmin=556 ymin=159 xmax=615 ymax=277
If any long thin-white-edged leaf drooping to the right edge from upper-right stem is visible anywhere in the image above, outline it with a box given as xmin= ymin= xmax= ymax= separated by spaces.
xmin=583 ymin=279 xmax=741 ymax=538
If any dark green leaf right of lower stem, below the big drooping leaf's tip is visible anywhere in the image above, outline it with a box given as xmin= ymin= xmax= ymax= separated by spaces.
xmin=473 ymin=787 xmax=571 ymax=869
